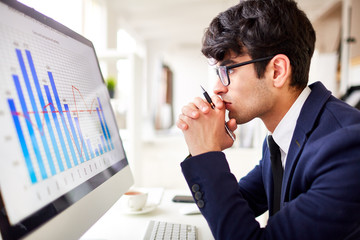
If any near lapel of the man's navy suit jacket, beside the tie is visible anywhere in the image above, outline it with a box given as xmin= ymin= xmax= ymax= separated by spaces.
xmin=281 ymin=82 xmax=331 ymax=202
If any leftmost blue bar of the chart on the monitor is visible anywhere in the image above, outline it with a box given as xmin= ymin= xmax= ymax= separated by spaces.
xmin=8 ymin=99 xmax=37 ymax=184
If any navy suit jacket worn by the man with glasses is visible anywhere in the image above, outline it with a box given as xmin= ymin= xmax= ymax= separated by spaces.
xmin=181 ymin=82 xmax=360 ymax=240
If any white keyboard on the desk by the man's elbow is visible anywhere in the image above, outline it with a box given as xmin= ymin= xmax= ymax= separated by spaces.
xmin=144 ymin=220 xmax=197 ymax=240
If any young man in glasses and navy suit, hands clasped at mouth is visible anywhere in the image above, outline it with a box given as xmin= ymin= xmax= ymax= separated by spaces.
xmin=177 ymin=0 xmax=360 ymax=240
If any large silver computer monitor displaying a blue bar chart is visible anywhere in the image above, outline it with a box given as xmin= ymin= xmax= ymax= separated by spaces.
xmin=0 ymin=0 xmax=133 ymax=240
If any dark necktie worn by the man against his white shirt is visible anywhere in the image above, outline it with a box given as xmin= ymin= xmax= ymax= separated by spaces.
xmin=268 ymin=135 xmax=284 ymax=215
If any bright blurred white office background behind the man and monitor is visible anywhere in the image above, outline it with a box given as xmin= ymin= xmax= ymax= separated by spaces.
xmin=21 ymin=0 xmax=360 ymax=191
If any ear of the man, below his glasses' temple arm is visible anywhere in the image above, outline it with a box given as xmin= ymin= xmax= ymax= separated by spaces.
xmin=270 ymin=54 xmax=291 ymax=88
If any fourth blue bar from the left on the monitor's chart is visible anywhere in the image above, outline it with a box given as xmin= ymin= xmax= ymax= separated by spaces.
xmin=25 ymin=50 xmax=64 ymax=172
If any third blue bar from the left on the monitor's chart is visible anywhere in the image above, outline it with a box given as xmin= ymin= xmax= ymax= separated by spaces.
xmin=16 ymin=49 xmax=56 ymax=175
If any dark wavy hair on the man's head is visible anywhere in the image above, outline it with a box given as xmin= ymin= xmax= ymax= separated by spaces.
xmin=202 ymin=0 xmax=316 ymax=89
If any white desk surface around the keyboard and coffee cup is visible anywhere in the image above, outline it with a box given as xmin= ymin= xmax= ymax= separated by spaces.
xmin=80 ymin=190 xmax=214 ymax=240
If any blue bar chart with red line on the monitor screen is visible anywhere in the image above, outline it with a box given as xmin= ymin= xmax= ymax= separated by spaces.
xmin=7 ymin=48 xmax=114 ymax=184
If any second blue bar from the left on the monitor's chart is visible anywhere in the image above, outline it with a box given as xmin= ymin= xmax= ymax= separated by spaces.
xmin=13 ymin=75 xmax=47 ymax=179
